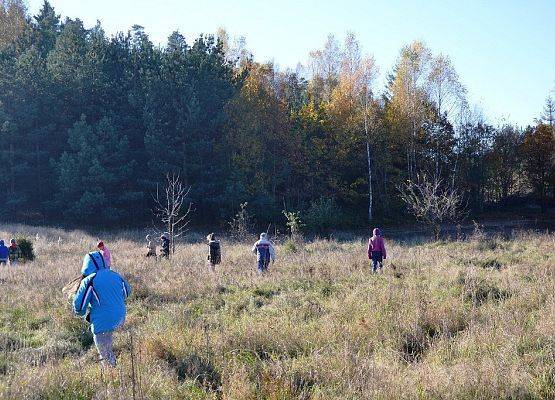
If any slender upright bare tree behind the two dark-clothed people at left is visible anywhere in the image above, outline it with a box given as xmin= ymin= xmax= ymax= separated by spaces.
xmin=152 ymin=174 xmax=193 ymax=253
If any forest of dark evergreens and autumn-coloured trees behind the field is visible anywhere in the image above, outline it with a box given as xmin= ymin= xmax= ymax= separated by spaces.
xmin=0 ymin=0 xmax=555 ymax=229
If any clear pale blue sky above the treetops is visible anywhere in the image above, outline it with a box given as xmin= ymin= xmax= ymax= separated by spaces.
xmin=28 ymin=0 xmax=555 ymax=125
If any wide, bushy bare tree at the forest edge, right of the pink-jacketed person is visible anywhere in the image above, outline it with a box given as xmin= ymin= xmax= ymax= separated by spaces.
xmin=399 ymin=175 xmax=464 ymax=239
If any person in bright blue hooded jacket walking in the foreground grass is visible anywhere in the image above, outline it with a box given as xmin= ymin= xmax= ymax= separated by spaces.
xmin=73 ymin=251 xmax=131 ymax=367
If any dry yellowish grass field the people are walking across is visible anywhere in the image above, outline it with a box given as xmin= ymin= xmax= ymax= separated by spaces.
xmin=0 ymin=226 xmax=555 ymax=399
